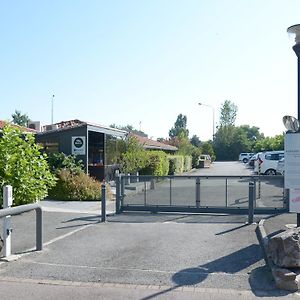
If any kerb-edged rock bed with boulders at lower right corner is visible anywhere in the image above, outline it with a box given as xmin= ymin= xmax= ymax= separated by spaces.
xmin=255 ymin=220 xmax=300 ymax=292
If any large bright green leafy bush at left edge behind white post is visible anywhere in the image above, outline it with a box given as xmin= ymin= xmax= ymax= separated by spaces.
xmin=0 ymin=125 xmax=56 ymax=205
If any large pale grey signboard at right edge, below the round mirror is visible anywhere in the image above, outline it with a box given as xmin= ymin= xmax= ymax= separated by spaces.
xmin=284 ymin=133 xmax=300 ymax=189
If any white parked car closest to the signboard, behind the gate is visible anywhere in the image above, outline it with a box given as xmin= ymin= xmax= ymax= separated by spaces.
xmin=254 ymin=150 xmax=284 ymax=175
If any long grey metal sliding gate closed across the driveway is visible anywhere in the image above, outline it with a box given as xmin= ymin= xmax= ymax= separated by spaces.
xmin=116 ymin=176 xmax=288 ymax=214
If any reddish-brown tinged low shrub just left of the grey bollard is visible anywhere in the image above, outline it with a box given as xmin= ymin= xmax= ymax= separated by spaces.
xmin=49 ymin=169 xmax=101 ymax=200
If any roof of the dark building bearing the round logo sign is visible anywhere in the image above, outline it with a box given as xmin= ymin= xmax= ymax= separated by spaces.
xmin=38 ymin=119 xmax=128 ymax=137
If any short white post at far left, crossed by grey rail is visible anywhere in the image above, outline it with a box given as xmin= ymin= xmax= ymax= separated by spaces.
xmin=3 ymin=185 xmax=13 ymax=257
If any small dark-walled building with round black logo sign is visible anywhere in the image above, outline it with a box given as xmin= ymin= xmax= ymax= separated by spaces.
xmin=36 ymin=119 xmax=127 ymax=181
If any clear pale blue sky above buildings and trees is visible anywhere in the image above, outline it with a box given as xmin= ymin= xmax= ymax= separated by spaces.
xmin=0 ymin=0 xmax=300 ymax=140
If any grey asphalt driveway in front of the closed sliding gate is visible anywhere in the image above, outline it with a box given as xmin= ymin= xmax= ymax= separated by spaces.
xmin=0 ymin=165 xmax=300 ymax=300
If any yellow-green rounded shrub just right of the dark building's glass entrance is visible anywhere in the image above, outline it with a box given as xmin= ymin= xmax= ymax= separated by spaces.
xmin=121 ymin=136 xmax=147 ymax=173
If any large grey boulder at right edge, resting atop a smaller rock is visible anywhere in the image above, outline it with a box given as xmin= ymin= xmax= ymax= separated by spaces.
xmin=268 ymin=227 xmax=300 ymax=268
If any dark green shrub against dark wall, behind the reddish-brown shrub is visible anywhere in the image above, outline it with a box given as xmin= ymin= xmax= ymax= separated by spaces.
xmin=48 ymin=152 xmax=83 ymax=174
